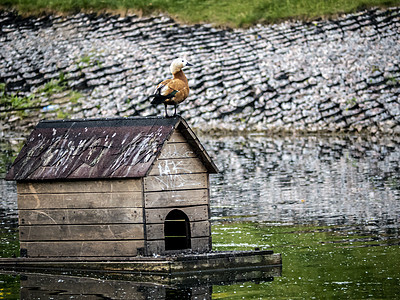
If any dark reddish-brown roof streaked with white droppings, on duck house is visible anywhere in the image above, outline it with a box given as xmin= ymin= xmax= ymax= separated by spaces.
xmin=6 ymin=117 xmax=218 ymax=181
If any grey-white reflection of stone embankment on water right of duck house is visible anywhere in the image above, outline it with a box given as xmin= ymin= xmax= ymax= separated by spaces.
xmin=205 ymin=136 xmax=400 ymax=226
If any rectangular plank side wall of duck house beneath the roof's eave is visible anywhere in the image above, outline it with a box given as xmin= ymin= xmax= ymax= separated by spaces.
xmin=17 ymin=179 xmax=144 ymax=257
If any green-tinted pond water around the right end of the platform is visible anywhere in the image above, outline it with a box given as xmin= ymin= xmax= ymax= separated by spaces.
xmin=213 ymin=222 xmax=400 ymax=299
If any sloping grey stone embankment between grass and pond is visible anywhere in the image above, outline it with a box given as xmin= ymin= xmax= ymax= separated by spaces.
xmin=0 ymin=8 xmax=400 ymax=134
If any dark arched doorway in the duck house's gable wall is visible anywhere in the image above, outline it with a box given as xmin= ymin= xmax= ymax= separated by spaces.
xmin=164 ymin=209 xmax=191 ymax=250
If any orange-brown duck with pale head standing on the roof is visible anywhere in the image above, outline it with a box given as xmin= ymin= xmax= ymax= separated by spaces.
xmin=149 ymin=58 xmax=193 ymax=118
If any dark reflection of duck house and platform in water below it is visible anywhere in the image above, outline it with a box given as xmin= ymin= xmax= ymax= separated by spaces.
xmin=0 ymin=267 xmax=281 ymax=300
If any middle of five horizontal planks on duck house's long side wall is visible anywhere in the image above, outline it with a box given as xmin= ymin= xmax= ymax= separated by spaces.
xmin=19 ymin=208 xmax=143 ymax=225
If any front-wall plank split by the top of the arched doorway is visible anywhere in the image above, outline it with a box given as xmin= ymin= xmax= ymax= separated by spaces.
xmin=145 ymin=205 xmax=208 ymax=224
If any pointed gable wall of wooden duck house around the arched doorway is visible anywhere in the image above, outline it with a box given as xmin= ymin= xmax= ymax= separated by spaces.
xmin=144 ymin=130 xmax=211 ymax=255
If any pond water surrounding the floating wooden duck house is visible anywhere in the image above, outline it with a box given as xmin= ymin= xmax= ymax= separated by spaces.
xmin=0 ymin=135 xmax=400 ymax=299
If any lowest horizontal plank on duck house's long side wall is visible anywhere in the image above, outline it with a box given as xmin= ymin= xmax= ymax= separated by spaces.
xmin=20 ymin=240 xmax=144 ymax=257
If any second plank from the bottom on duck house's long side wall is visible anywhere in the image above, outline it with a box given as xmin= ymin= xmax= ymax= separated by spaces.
xmin=19 ymin=224 xmax=144 ymax=241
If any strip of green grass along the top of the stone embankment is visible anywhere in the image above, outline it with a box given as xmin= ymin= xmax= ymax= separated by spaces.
xmin=0 ymin=0 xmax=400 ymax=27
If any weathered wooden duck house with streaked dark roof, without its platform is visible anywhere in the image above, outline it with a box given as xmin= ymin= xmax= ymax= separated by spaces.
xmin=6 ymin=117 xmax=217 ymax=257
